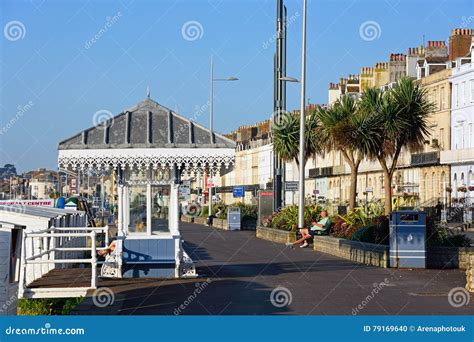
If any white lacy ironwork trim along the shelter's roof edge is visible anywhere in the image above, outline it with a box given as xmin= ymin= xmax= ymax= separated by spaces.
xmin=58 ymin=148 xmax=235 ymax=173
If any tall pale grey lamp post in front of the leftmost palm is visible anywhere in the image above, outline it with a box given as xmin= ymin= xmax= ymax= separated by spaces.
xmin=298 ymin=0 xmax=306 ymax=228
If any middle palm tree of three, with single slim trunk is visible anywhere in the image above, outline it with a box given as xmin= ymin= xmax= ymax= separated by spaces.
xmin=317 ymin=95 xmax=378 ymax=210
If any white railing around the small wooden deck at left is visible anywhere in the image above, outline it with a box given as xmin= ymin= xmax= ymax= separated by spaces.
xmin=18 ymin=226 xmax=109 ymax=298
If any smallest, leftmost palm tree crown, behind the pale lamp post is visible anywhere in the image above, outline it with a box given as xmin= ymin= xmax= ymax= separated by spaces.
xmin=272 ymin=112 xmax=322 ymax=167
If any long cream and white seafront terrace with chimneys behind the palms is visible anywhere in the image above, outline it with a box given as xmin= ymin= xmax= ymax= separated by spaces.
xmin=217 ymin=29 xmax=474 ymax=211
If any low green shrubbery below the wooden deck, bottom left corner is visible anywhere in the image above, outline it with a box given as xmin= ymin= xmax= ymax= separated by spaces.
xmin=18 ymin=297 xmax=84 ymax=316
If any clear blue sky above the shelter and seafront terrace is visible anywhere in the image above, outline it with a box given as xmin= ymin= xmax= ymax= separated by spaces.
xmin=0 ymin=0 xmax=474 ymax=171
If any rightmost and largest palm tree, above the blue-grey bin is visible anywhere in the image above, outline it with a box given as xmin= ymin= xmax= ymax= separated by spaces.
xmin=361 ymin=78 xmax=434 ymax=215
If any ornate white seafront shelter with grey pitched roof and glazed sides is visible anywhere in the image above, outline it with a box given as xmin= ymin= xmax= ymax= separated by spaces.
xmin=58 ymin=98 xmax=235 ymax=277
